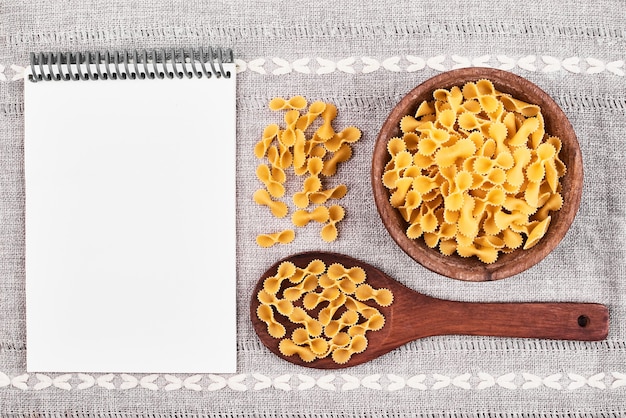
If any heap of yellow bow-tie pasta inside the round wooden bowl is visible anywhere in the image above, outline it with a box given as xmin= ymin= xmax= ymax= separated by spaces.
xmin=381 ymin=79 xmax=566 ymax=263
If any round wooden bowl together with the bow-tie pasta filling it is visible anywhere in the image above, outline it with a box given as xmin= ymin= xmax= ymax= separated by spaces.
xmin=371 ymin=68 xmax=583 ymax=281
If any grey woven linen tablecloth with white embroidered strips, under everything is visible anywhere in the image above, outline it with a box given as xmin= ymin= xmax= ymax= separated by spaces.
xmin=0 ymin=0 xmax=626 ymax=417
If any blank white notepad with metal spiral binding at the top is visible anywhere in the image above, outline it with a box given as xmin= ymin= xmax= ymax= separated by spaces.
xmin=24 ymin=48 xmax=236 ymax=373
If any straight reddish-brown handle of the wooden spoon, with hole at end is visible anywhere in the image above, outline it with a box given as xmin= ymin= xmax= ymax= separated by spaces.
xmin=426 ymin=300 xmax=609 ymax=341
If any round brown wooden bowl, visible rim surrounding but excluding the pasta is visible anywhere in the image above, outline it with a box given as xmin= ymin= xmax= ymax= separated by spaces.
xmin=371 ymin=68 xmax=583 ymax=282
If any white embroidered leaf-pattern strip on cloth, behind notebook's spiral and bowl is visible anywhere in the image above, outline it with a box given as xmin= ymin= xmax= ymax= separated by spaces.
xmin=0 ymin=55 xmax=626 ymax=81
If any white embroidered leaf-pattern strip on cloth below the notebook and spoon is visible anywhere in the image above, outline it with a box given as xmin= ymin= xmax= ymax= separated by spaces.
xmin=0 ymin=372 xmax=626 ymax=392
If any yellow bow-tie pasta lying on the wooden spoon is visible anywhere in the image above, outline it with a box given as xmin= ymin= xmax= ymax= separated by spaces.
xmin=257 ymin=260 xmax=393 ymax=364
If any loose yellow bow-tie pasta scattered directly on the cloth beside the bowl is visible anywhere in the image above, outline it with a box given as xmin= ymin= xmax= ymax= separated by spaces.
xmin=253 ymin=96 xmax=361 ymax=247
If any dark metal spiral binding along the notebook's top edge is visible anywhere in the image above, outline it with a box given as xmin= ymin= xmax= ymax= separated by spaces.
xmin=28 ymin=47 xmax=234 ymax=82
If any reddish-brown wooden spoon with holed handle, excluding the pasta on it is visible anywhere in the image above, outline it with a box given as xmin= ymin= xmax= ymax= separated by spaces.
xmin=250 ymin=252 xmax=609 ymax=369
